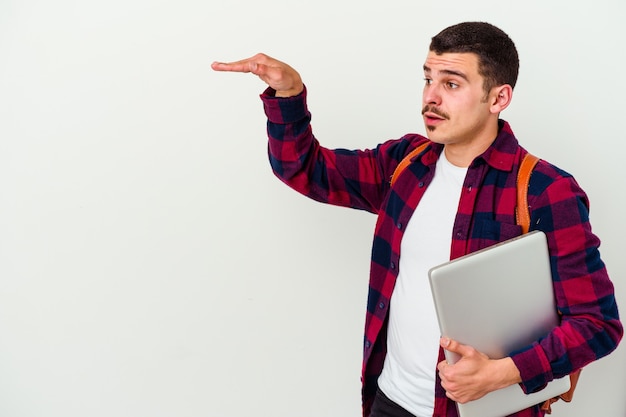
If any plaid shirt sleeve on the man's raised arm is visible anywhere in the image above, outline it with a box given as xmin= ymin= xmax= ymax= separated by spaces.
xmin=261 ymin=87 xmax=387 ymax=213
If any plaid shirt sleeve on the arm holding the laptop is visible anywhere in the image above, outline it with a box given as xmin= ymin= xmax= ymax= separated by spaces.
xmin=511 ymin=163 xmax=623 ymax=393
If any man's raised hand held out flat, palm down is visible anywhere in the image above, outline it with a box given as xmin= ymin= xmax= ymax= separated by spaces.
xmin=211 ymin=54 xmax=304 ymax=97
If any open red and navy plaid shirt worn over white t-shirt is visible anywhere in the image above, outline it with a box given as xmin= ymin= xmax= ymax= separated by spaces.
xmin=261 ymin=89 xmax=623 ymax=417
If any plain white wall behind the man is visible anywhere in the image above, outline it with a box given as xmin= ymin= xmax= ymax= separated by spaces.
xmin=0 ymin=0 xmax=626 ymax=417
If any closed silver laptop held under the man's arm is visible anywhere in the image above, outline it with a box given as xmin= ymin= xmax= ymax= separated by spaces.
xmin=429 ymin=231 xmax=570 ymax=417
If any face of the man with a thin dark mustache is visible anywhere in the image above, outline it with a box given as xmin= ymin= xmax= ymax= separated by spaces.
xmin=422 ymin=51 xmax=497 ymax=145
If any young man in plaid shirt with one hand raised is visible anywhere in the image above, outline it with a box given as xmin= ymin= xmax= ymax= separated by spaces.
xmin=212 ymin=22 xmax=623 ymax=417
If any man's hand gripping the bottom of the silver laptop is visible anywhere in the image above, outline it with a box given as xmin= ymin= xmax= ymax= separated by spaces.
xmin=437 ymin=337 xmax=521 ymax=404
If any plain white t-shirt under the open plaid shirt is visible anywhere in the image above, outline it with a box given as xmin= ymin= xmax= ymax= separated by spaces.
xmin=378 ymin=152 xmax=467 ymax=417
